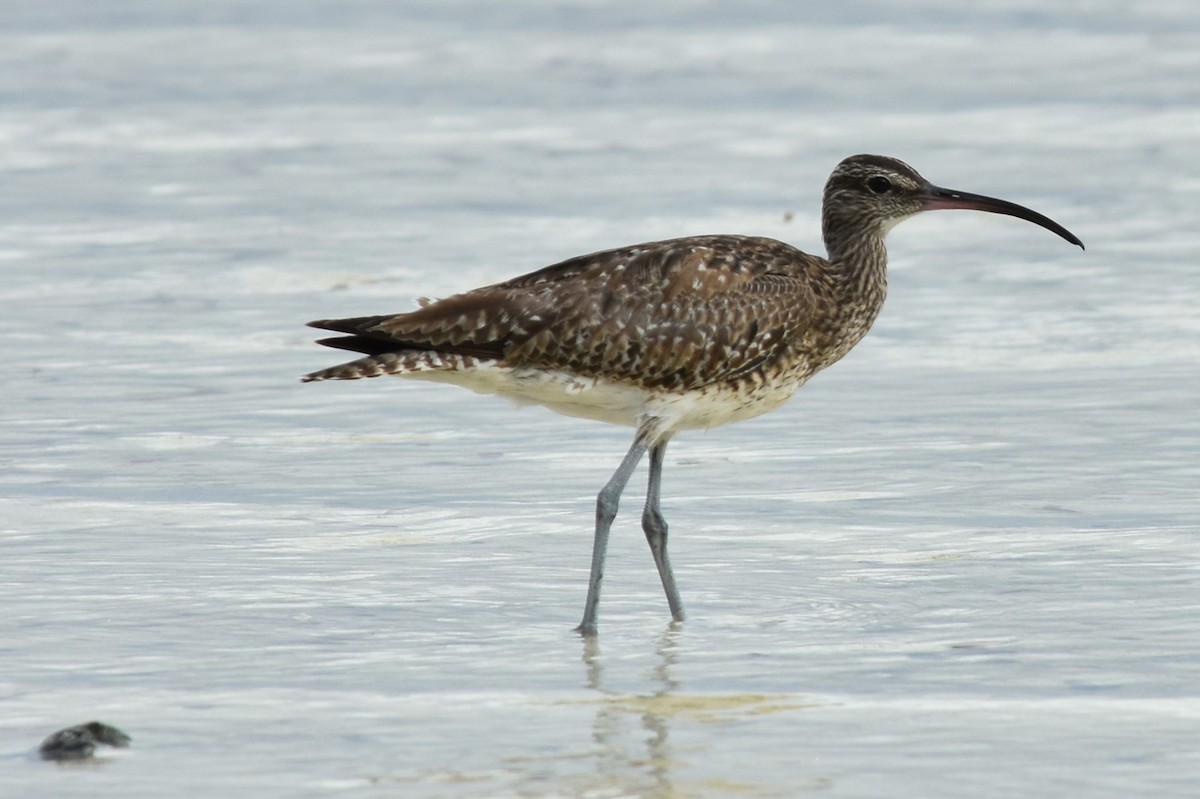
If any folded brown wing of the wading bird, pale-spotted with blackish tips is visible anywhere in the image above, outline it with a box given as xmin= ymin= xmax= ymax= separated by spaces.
xmin=310 ymin=236 xmax=817 ymax=389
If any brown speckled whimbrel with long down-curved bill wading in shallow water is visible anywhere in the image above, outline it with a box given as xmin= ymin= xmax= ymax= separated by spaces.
xmin=304 ymin=155 xmax=1084 ymax=636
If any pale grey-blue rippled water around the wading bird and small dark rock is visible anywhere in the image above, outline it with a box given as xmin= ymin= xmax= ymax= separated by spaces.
xmin=0 ymin=0 xmax=1200 ymax=799
